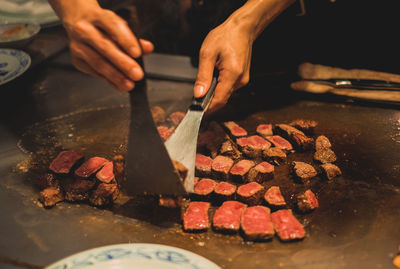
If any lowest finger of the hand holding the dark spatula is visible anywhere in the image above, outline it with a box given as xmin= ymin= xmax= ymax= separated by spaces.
xmin=70 ymin=42 xmax=135 ymax=91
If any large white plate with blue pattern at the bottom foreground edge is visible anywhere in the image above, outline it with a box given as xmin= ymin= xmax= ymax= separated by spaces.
xmin=45 ymin=244 xmax=221 ymax=269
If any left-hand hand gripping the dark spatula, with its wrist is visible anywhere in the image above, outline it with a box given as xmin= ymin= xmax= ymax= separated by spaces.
xmin=49 ymin=0 xmax=154 ymax=91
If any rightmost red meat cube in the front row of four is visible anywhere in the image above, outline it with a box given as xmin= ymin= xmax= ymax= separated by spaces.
xmin=271 ymin=209 xmax=306 ymax=241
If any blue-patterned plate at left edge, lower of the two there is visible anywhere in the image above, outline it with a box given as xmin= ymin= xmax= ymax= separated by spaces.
xmin=0 ymin=49 xmax=31 ymax=85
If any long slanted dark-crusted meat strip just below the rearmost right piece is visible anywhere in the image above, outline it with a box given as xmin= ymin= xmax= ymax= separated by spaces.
xmin=276 ymin=124 xmax=314 ymax=151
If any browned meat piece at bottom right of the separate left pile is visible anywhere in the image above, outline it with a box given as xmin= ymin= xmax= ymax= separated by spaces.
xmin=89 ymin=183 xmax=119 ymax=207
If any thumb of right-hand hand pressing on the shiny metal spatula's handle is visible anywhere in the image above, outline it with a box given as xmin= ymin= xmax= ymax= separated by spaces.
xmin=193 ymin=49 xmax=216 ymax=98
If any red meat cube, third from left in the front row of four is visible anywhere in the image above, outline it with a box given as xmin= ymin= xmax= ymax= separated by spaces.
xmin=240 ymin=206 xmax=275 ymax=241
